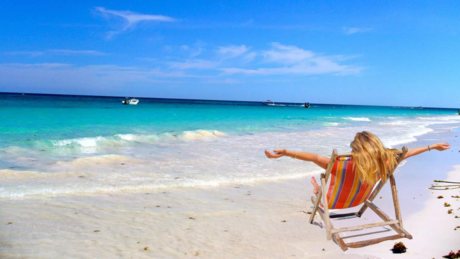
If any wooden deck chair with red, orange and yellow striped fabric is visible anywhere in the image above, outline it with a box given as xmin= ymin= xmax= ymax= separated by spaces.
xmin=310 ymin=147 xmax=412 ymax=251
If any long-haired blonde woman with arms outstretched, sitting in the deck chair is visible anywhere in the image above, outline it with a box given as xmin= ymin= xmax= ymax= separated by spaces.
xmin=265 ymin=131 xmax=450 ymax=194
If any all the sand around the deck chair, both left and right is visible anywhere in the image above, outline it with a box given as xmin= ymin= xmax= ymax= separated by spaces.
xmin=0 ymin=125 xmax=460 ymax=258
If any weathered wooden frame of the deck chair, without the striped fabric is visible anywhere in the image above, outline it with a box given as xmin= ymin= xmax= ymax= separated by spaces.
xmin=310 ymin=147 xmax=412 ymax=251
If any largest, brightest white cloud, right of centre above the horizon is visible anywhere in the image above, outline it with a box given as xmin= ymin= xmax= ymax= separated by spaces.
xmin=167 ymin=42 xmax=364 ymax=75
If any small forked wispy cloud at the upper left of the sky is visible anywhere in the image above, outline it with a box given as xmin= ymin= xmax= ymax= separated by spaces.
xmin=95 ymin=7 xmax=177 ymax=37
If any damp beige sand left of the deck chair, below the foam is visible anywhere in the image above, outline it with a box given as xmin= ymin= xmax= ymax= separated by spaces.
xmin=0 ymin=179 xmax=367 ymax=258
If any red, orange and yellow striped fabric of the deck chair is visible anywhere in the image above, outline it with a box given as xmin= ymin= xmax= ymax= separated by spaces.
xmin=327 ymin=157 xmax=375 ymax=209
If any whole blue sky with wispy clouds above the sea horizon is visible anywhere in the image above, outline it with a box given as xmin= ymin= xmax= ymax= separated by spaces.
xmin=0 ymin=0 xmax=460 ymax=107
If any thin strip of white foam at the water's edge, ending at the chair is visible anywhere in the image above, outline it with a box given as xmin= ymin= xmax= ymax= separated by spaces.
xmin=0 ymin=165 xmax=322 ymax=198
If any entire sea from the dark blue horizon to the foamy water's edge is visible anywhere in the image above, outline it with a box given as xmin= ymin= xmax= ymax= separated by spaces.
xmin=0 ymin=93 xmax=460 ymax=199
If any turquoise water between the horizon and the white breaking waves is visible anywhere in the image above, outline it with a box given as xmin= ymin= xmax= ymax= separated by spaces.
xmin=0 ymin=94 xmax=456 ymax=147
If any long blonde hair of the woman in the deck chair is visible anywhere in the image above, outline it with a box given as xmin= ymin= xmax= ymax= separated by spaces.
xmin=350 ymin=131 xmax=398 ymax=184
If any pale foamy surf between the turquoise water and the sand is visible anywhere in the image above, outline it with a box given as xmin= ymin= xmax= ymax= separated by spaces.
xmin=0 ymin=116 xmax=459 ymax=197
